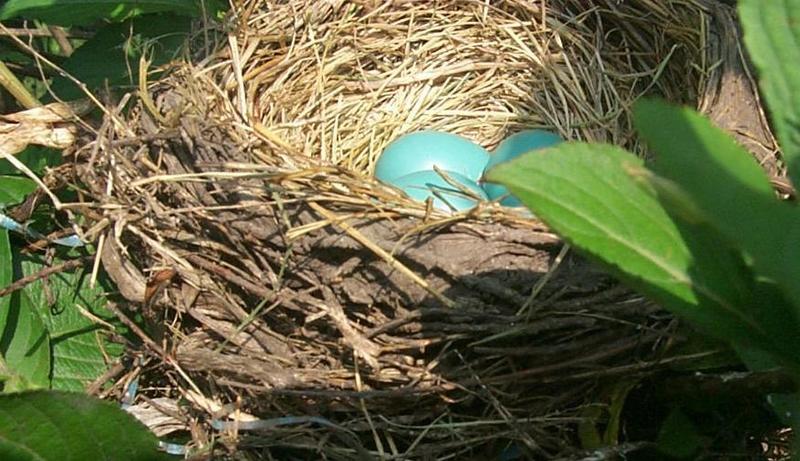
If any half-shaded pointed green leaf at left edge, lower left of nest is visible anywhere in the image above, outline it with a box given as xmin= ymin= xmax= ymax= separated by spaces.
xmin=0 ymin=292 xmax=50 ymax=391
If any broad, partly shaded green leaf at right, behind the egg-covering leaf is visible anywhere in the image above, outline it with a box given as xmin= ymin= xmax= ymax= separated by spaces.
xmin=634 ymin=101 xmax=800 ymax=350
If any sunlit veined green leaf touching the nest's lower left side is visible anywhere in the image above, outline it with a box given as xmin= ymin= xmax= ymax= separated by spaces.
xmin=21 ymin=258 xmax=122 ymax=391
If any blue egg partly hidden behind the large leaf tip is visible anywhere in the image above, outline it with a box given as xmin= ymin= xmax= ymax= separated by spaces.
xmin=483 ymin=130 xmax=563 ymax=206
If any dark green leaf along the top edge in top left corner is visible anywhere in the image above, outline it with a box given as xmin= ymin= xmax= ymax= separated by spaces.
xmin=0 ymin=0 xmax=209 ymax=26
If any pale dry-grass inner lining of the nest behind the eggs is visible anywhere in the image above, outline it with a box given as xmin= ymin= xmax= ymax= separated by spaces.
xmin=215 ymin=0 xmax=708 ymax=173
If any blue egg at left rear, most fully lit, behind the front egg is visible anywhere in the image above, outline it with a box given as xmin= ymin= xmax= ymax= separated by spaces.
xmin=375 ymin=131 xmax=489 ymax=182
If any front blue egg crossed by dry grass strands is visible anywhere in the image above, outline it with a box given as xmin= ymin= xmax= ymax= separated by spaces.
xmin=387 ymin=170 xmax=487 ymax=211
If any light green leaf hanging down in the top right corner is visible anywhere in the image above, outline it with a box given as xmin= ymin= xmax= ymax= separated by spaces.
xmin=739 ymin=0 xmax=800 ymax=186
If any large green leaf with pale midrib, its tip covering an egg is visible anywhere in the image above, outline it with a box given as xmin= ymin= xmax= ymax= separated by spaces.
xmin=489 ymin=144 xmax=774 ymax=356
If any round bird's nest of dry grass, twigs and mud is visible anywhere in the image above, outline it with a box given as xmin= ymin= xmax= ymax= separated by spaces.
xmin=65 ymin=0 xmax=778 ymax=459
